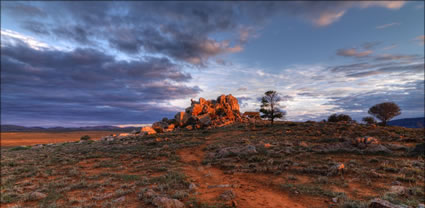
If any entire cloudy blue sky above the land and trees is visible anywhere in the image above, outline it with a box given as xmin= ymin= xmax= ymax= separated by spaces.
xmin=1 ymin=1 xmax=424 ymax=127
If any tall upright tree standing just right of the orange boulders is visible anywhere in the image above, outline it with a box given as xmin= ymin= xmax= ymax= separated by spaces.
xmin=260 ymin=90 xmax=286 ymax=126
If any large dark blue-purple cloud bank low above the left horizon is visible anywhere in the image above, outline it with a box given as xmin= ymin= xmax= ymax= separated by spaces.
xmin=1 ymin=41 xmax=201 ymax=125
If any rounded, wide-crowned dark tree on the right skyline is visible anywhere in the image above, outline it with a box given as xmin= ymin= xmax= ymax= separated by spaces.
xmin=368 ymin=102 xmax=401 ymax=126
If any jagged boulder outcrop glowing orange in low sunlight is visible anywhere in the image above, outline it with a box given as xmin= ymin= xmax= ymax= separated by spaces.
xmin=141 ymin=94 xmax=243 ymax=134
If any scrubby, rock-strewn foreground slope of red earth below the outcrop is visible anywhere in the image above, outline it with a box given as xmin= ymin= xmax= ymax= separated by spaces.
xmin=1 ymin=122 xmax=425 ymax=208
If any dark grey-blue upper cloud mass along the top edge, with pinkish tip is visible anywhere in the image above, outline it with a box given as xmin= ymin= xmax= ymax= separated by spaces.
xmin=5 ymin=2 xmax=403 ymax=66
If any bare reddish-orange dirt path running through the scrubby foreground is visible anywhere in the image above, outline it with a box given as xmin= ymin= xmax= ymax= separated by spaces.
xmin=178 ymin=132 xmax=314 ymax=208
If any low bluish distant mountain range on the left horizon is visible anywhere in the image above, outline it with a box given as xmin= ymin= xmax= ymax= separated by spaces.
xmin=1 ymin=125 xmax=140 ymax=132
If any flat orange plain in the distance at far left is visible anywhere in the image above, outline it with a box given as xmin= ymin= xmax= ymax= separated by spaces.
xmin=1 ymin=131 xmax=124 ymax=146
